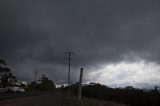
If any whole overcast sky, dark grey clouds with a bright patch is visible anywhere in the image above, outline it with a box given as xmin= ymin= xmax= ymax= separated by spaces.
xmin=0 ymin=0 xmax=160 ymax=87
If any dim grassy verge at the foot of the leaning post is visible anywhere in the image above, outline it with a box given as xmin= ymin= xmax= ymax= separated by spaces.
xmin=61 ymin=94 xmax=127 ymax=106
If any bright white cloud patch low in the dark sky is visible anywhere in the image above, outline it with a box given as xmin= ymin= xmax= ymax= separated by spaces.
xmin=89 ymin=60 xmax=160 ymax=87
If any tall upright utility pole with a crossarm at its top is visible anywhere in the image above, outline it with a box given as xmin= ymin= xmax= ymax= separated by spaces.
xmin=65 ymin=51 xmax=75 ymax=95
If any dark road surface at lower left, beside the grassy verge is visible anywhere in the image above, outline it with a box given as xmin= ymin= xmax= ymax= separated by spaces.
xmin=0 ymin=92 xmax=62 ymax=106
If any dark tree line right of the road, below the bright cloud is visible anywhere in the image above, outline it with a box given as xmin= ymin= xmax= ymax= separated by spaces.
xmin=59 ymin=83 xmax=160 ymax=106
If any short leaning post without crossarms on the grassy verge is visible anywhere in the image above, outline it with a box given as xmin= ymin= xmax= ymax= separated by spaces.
xmin=78 ymin=68 xmax=83 ymax=100
